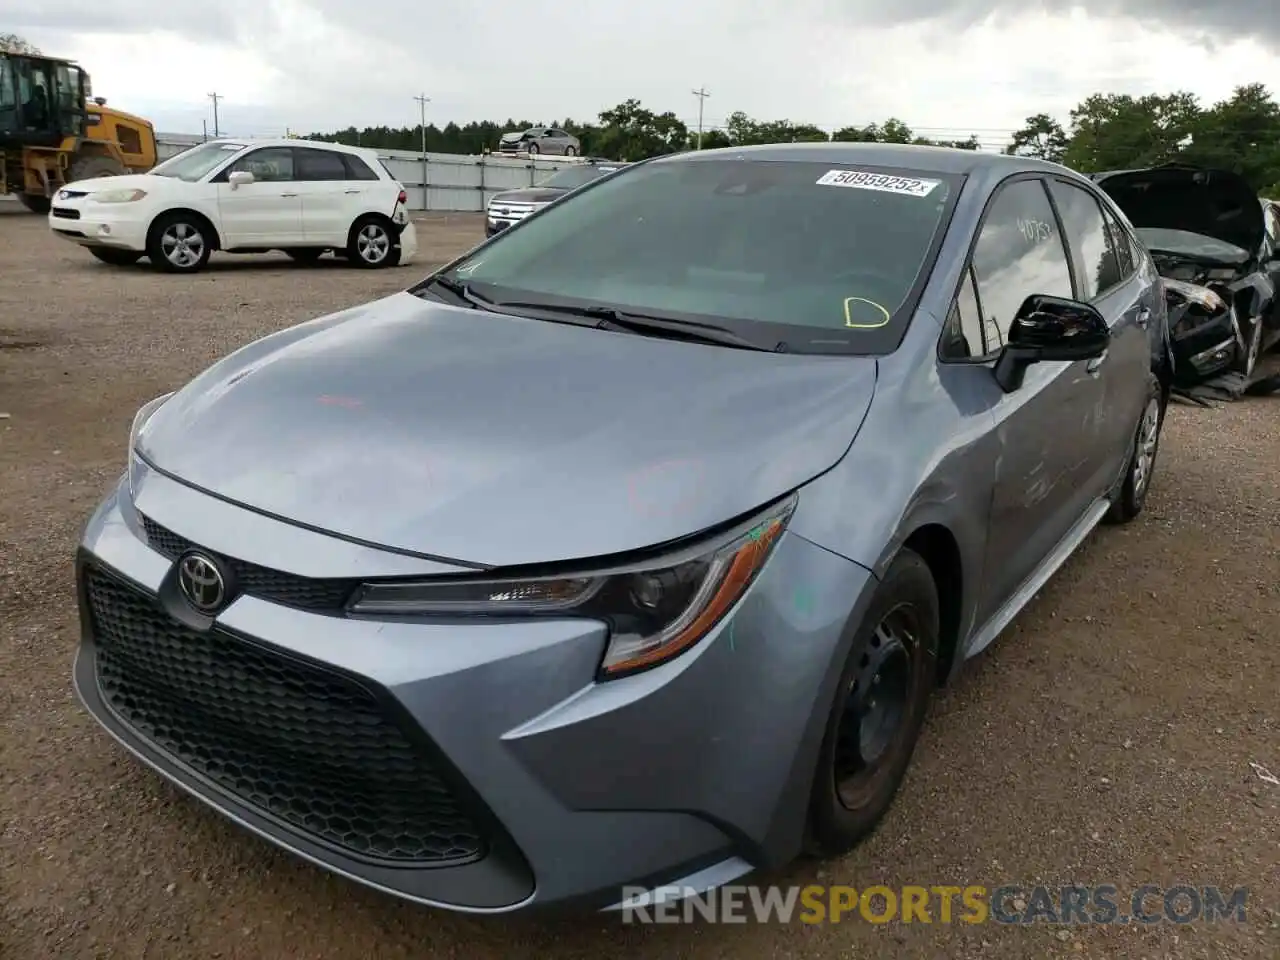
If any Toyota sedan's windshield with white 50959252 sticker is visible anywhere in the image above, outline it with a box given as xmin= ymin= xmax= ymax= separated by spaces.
xmin=445 ymin=157 xmax=961 ymax=353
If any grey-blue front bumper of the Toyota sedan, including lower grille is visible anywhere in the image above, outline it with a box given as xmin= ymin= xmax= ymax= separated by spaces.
xmin=67 ymin=471 xmax=870 ymax=911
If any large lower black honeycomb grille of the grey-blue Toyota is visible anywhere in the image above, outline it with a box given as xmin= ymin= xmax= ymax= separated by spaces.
xmin=84 ymin=567 xmax=486 ymax=867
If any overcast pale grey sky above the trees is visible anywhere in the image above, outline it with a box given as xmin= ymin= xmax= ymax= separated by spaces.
xmin=0 ymin=0 xmax=1280 ymax=142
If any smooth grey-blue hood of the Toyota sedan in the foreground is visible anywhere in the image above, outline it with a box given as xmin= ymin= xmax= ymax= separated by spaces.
xmin=137 ymin=293 xmax=877 ymax=566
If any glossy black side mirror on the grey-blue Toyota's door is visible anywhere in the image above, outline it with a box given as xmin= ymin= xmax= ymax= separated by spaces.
xmin=995 ymin=294 xmax=1111 ymax=393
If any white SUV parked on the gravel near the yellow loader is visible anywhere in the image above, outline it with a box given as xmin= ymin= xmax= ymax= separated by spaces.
xmin=49 ymin=140 xmax=417 ymax=273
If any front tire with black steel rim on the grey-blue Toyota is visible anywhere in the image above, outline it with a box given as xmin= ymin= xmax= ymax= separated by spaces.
xmin=805 ymin=549 xmax=940 ymax=858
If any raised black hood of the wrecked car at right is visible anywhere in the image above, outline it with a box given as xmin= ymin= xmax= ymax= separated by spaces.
xmin=1093 ymin=166 xmax=1266 ymax=253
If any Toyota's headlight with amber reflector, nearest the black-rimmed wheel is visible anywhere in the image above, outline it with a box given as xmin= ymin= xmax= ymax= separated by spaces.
xmin=351 ymin=497 xmax=795 ymax=680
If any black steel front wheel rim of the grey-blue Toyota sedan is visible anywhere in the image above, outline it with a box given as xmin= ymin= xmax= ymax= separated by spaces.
xmin=832 ymin=607 xmax=919 ymax=810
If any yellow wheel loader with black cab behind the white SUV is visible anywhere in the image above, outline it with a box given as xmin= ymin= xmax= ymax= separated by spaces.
xmin=0 ymin=51 xmax=156 ymax=214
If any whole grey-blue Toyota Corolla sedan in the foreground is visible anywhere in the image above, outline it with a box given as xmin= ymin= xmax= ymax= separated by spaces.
xmin=67 ymin=143 xmax=1170 ymax=911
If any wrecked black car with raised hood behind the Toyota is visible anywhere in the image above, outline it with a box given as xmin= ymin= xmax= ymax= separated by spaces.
xmin=1093 ymin=164 xmax=1280 ymax=393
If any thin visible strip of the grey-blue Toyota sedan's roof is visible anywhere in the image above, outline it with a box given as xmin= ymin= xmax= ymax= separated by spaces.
xmin=659 ymin=142 xmax=1078 ymax=175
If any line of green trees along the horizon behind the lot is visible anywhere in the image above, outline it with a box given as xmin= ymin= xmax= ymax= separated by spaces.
xmin=311 ymin=83 xmax=1280 ymax=198
